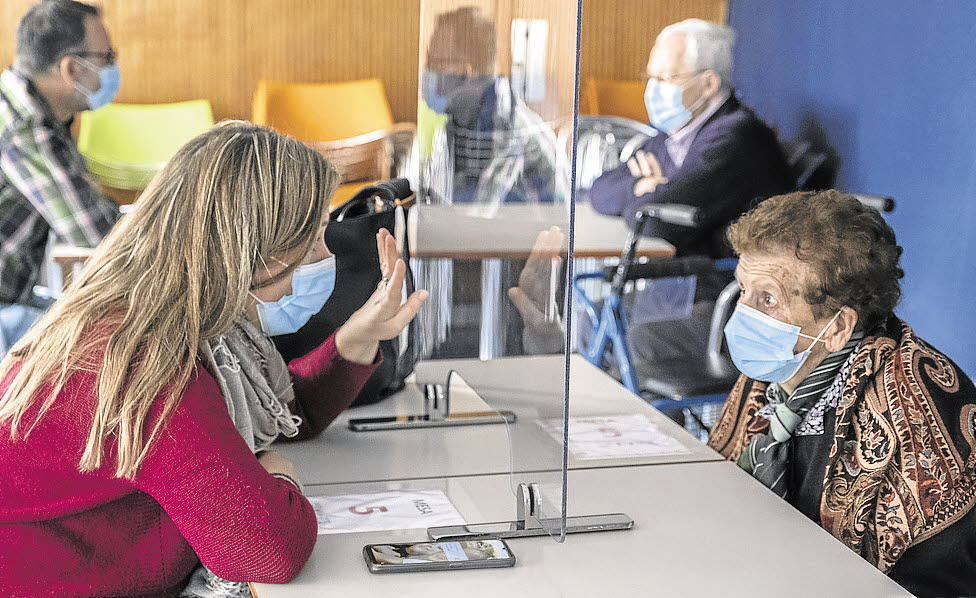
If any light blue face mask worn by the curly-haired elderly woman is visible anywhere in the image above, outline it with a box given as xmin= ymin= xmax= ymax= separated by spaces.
xmin=725 ymin=303 xmax=840 ymax=382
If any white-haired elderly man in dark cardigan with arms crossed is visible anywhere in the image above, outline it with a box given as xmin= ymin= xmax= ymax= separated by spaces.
xmin=590 ymin=19 xmax=794 ymax=394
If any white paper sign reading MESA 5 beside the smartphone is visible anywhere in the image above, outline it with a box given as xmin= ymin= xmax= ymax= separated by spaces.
xmin=308 ymin=490 xmax=465 ymax=534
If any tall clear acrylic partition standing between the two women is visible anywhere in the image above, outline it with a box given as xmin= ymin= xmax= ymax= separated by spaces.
xmin=408 ymin=0 xmax=578 ymax=540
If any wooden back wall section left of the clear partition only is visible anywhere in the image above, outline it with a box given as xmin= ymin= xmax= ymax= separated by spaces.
xmin=0 ymin=0 xmax=420 ymax=121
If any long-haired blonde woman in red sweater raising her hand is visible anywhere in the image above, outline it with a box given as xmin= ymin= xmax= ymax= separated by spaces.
xmin=0 ymin=123 xmax=426 ymax=597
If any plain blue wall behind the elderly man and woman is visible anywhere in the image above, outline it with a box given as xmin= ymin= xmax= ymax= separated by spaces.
xmin=729 ymin=0 xmax=976 ymax=376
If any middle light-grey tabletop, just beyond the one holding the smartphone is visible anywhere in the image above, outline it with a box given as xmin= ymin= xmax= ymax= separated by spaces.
xmin=277 ymin=355 xmax=721 ymax=484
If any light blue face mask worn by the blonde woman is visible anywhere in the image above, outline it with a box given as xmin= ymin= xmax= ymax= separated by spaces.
xmin=251 ymin=256 xmax=336 ymax=336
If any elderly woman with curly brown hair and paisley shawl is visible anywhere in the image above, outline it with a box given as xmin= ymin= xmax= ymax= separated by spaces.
xmin=709 ymin=191 xmax=976 ymax=596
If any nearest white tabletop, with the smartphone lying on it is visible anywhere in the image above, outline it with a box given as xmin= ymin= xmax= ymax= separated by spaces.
xmin=255 ymin=462 xmax=910 ymax=598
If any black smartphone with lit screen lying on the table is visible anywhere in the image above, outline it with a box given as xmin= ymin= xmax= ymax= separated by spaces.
xmin=363 ymin=538 xmax=515 ymax=573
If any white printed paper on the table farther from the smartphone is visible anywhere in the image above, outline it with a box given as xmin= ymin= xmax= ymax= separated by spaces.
xmin=539 ymin=414 xmax=689 ymax=461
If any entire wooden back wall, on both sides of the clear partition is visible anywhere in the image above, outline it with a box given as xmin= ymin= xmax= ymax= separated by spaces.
xmin=0 ymin=0 xmax=726 ymax=121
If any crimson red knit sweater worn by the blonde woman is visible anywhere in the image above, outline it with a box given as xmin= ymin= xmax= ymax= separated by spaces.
xmin=0 ymin=337 xmax=375 ymax=598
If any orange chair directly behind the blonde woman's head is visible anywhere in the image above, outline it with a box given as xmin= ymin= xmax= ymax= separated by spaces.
xmin=252 ymin=79 xmax=416 ymax=208
